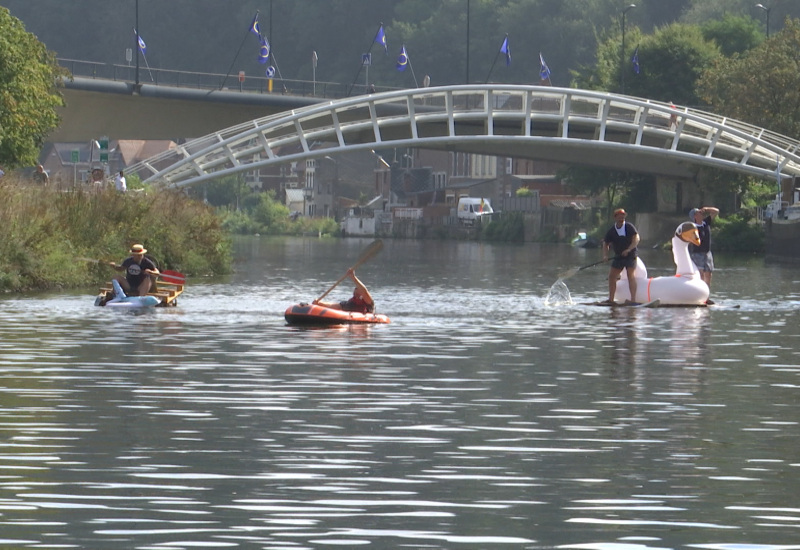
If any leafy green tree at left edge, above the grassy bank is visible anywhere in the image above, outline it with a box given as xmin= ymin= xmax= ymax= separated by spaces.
xmin=0 ymin=7 xmax=67 ymax=168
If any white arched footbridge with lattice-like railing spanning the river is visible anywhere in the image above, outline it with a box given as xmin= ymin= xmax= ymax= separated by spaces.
xmin=123 ymin=84 xmax=800 ymax=187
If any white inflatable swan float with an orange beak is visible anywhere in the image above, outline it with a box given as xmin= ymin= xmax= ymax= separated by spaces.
xmin=615 ymin=222 xmax=709 ymax=306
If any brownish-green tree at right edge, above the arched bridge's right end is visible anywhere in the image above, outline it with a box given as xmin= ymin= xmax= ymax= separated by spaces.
xmin=698 ymin=19 xmax=800 ymax=140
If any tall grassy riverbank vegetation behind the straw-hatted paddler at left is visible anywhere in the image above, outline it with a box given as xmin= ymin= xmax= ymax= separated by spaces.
xmin=0 ymin=176 xmax=232 ymax=292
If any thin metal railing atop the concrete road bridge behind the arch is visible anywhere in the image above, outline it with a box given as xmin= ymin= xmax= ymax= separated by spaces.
xmin=58 ymin=58 xmax=364 ymax=99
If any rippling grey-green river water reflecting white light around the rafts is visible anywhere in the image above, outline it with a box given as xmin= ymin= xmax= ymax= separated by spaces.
xmin=0 ymin=239 xmax=800 ymax=550
